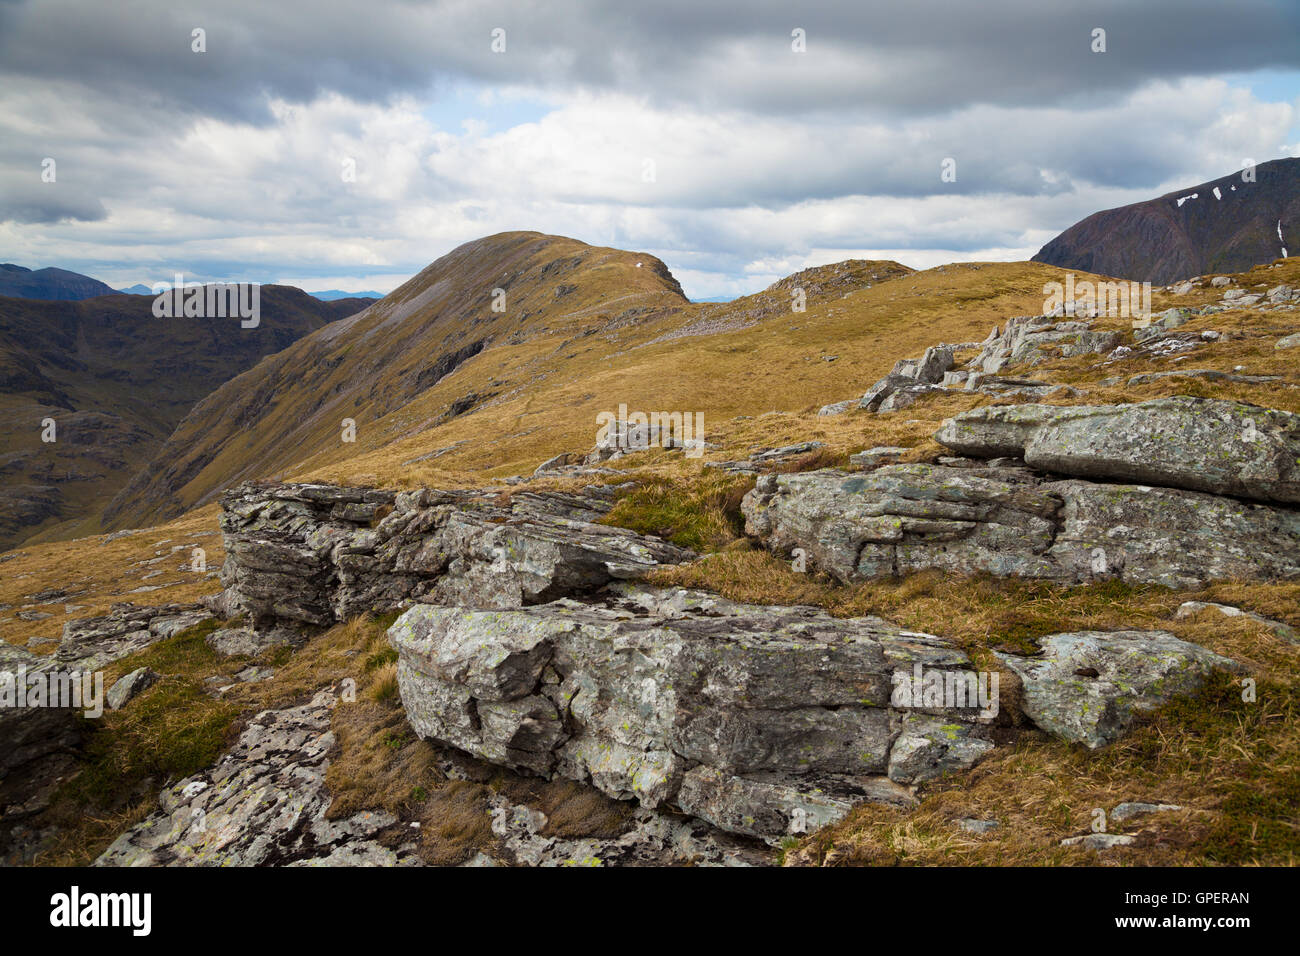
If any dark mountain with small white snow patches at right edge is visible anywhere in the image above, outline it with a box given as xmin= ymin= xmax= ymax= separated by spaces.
xmin=1034 ymin=159 xmax=1300 ymax=284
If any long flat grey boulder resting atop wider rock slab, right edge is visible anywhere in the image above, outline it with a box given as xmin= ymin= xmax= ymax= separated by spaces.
xmin=935 ymin=395 xmax=1300 ymax=503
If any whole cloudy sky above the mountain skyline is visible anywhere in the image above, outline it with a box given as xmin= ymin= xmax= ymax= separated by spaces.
xmin=0 ymin=0 xmax=1300 ymax=299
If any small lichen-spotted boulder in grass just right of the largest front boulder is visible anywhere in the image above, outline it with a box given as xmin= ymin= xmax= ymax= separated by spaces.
xmin=997 ymin=631 xmax=1238 ymax=749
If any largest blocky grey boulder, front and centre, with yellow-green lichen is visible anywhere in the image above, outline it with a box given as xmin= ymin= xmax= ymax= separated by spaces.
xmin=389 ymin=584 xmax=996 ymax=839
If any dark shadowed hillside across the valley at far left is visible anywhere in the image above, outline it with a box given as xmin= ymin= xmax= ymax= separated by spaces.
xmin=0 ymin=286 xmax=377 ymax=546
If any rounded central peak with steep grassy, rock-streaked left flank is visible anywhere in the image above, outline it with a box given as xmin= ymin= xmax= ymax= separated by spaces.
xmin=107 ymin=233 xmax=689 ymax=527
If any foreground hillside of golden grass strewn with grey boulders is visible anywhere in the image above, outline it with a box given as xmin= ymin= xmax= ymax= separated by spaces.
xmin=0 ymin=244 xmax=1300 ymax=866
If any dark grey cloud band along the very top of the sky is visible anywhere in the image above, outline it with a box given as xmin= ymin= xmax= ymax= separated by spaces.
xmin=0 ymin=0 xmax=1300 ymax=121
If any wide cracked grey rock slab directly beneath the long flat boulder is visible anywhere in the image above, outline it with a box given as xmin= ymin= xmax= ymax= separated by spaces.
xmin=741 ymin=465 xmax=1300 ymax=588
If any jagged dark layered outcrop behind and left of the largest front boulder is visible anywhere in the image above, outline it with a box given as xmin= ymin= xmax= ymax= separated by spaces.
xmin=221 ymin=484 xmax=690 ymax=631
